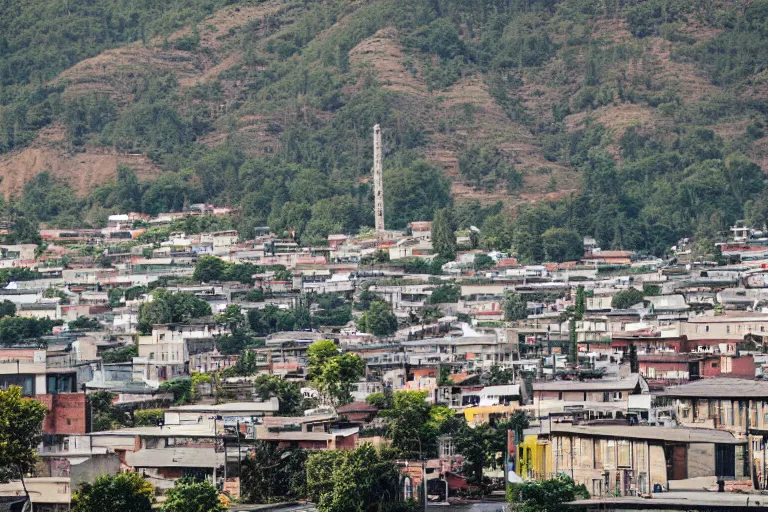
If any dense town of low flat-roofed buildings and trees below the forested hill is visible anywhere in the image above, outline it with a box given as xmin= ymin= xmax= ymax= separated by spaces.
xmin=0 ymin=195 xmax=768 ymax=512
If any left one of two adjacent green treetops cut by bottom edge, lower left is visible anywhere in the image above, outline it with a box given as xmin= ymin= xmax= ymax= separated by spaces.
xmin=72 ymin=472 xmax=153 ymax=512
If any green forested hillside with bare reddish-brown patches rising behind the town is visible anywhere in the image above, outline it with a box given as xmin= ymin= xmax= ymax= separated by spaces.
xmin=0 ymin=0 xmax=768 ymax=261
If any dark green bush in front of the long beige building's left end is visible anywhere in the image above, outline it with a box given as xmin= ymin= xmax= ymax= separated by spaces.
xmin=507 ymin=474 xmax=589 ymax=512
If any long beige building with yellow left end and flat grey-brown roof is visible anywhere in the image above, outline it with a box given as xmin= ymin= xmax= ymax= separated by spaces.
xmin=516 ymin=425 xmax=748 ymax=496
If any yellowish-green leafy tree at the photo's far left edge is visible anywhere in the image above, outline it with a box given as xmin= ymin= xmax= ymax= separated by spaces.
xmin=0 ymin=386 xmax=46 ymax=499
